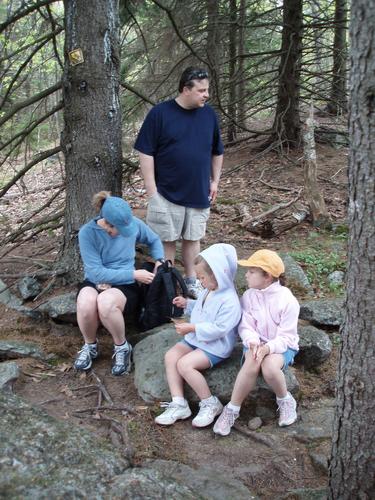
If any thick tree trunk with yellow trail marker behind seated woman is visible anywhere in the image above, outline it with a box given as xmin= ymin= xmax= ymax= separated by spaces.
xmin=61 ymin=0 xmax=122 ymax=276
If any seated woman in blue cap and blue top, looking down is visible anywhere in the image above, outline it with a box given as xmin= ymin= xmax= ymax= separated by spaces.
xmin=74 ymin=191 xmax=164 ymax=375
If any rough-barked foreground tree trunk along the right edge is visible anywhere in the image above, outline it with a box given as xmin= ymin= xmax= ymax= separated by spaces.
xmin=329 ymin=0 xmax=375 ymax=500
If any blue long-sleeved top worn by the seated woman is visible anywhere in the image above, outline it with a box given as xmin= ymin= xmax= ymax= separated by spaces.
xmin=78 ymin=217 xmax=164 ymax=285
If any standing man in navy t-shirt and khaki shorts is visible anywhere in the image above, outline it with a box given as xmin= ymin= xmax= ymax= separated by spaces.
xmin=134 ymin=67 xmax=224 ymax=298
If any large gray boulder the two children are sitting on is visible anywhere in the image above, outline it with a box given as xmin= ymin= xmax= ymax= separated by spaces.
xmin=133 ymin=324 xmax=299 ymax=402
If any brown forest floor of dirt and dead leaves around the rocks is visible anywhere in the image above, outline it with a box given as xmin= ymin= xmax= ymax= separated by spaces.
xmin=0 ymin=136 xmax=348 ymax=498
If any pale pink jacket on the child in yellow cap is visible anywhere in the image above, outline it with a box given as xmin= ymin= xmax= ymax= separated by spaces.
xmin=238 ymin=281 xmax=299 ymax=354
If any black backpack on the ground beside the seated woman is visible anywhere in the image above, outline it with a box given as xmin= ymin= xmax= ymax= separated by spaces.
xmin=139 ymin=260 xmax=187 ymax=331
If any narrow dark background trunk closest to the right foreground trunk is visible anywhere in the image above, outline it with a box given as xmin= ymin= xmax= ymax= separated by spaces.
xmin=327 ymin=0 xmax=348 ymax=115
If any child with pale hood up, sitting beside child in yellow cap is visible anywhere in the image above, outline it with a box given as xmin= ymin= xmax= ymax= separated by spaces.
xmin=155 ymin=243 xmax=241 ymax=427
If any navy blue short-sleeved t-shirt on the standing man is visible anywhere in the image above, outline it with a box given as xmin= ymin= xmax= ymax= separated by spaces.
xmin=134 ymin=100 xmax=224 ymax=208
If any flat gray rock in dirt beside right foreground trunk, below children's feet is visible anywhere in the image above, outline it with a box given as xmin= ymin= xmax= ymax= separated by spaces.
xmin=282 ymin=398 xmax=335 ymax=443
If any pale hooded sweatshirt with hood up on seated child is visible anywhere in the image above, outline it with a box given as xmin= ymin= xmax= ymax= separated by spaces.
xmin=185 ymin=243 xmax=241 ymax=358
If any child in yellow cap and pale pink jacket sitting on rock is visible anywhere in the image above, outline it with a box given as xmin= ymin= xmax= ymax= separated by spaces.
xmin=214 ymin=250 xmax=299 ymax=436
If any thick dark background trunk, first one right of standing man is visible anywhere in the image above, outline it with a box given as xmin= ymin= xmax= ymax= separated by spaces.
xmin=272 ymin=0 xmax=302 ymax=147
